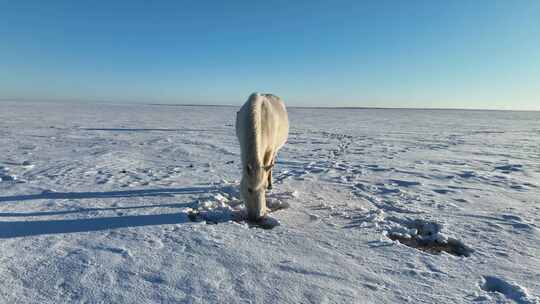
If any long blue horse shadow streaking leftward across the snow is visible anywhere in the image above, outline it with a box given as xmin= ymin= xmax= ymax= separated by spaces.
xmin=0 ymin=186 xmax=225 ymax=239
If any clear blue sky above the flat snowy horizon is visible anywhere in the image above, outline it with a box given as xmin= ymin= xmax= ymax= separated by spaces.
xmin=0 ymin=0 xmax=540 ymax=110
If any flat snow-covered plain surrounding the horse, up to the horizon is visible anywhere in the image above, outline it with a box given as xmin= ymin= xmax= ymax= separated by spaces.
xmin=0 ymin=102 xmax=540 ymax=303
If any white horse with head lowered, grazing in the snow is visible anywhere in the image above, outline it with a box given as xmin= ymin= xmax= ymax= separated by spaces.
xmin=236 ymin=93 xmax=289 ymax=221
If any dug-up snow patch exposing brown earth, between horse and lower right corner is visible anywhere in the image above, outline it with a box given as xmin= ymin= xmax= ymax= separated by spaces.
xmin=387 ymin=220 xmax=474 ymax=257
